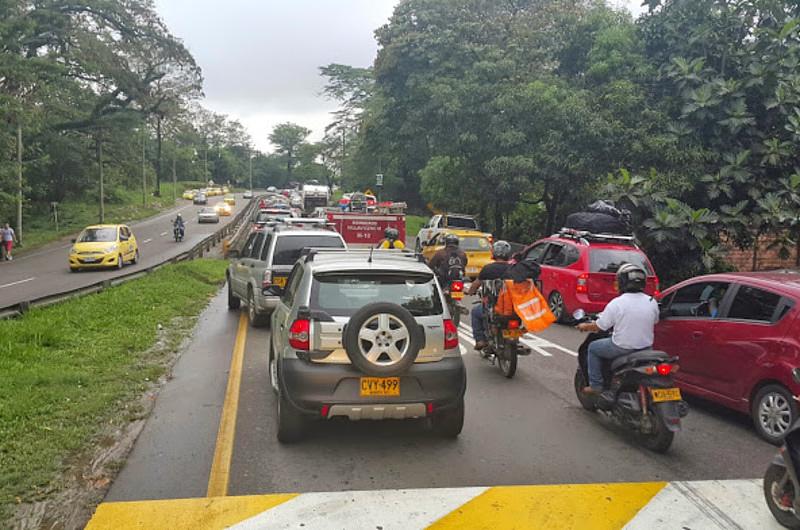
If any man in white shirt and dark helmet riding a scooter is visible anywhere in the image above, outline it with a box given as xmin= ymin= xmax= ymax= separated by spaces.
xmin=578 ymin=263 xmax=658 ymax=395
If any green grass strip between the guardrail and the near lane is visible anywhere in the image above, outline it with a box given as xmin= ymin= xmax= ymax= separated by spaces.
xmin=0 ymin=259 xmax=227 ymax=516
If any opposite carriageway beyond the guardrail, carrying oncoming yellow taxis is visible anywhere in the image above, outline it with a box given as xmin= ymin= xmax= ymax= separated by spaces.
xmin=0 ymin=194 xmax=249 ymax=307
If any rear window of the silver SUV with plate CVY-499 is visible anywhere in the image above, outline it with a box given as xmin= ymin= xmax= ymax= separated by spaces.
xmin=311 ymin=273 xmax=443 ymax=316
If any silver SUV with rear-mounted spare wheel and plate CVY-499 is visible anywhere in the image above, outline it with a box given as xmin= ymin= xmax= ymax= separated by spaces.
xmin=269 ymin=249 xmax=467 ymax=442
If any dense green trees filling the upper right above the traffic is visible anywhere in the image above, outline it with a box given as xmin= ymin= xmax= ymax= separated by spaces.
xmin=328 ymin=0 xmax=800 ymax=278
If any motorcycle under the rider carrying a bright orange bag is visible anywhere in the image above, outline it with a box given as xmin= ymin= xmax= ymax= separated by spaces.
xmin=476 ymin=280 xmax=530 ymax=379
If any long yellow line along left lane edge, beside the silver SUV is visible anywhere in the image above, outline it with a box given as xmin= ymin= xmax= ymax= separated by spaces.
xmin=206 ymin=312 xmax=247 ymax=497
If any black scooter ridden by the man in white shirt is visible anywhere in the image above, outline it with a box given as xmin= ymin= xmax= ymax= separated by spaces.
xmin=572 ymin=309 xmax=689 ymax=453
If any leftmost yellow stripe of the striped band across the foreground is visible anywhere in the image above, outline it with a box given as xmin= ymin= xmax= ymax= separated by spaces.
xmin=86 ymin=494 xmax=297 ymax=530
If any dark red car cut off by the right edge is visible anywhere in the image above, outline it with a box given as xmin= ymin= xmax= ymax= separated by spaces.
xmin=655 ymin=272 xmax=800 ymax=443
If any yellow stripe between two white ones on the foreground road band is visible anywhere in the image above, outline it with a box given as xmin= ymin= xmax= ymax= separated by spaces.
xmin=429 ymin=482 xmax=667 ymax=530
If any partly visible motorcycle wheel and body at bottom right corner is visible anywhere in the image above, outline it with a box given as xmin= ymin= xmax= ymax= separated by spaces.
xmin=764 ymin=404 xmax=800 ymax=528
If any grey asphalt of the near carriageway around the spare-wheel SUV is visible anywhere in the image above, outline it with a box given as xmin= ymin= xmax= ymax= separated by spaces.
xmin=106 ymin=291 xmax=774 ymax=500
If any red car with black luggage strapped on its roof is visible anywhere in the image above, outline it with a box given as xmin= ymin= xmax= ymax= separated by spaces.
xmin=515 ymin=229 xmax=658 ymax=322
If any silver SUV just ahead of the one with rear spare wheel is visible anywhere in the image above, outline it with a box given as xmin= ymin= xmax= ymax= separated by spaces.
xmin=226 ymin=219 xmax=347 ymax=327
